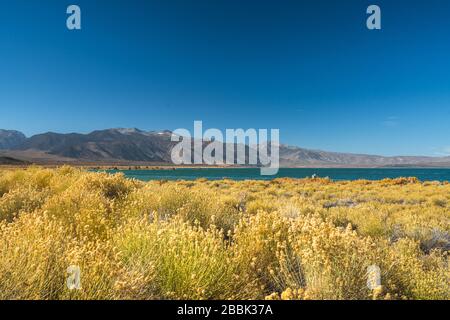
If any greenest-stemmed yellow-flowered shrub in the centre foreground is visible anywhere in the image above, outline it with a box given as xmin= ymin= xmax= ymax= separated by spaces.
xmin=116 ymin=215 xmax=253 ymax=299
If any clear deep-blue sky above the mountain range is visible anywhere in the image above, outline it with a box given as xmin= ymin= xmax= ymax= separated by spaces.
xmin=0 ymin=0 xmax=450 ymax=155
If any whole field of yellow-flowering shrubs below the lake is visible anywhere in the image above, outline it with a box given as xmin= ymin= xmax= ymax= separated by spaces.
xmin=0 ymin=166 xmax=450 ymax=300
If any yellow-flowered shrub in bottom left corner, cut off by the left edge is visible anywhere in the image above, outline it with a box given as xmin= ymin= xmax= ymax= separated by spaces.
xmin=0 ymin=214 xmax=70 ymax=300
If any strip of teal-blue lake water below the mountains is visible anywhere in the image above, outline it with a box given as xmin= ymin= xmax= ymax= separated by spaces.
xmin=103 ymin=168 xmax=450 ymax=181
